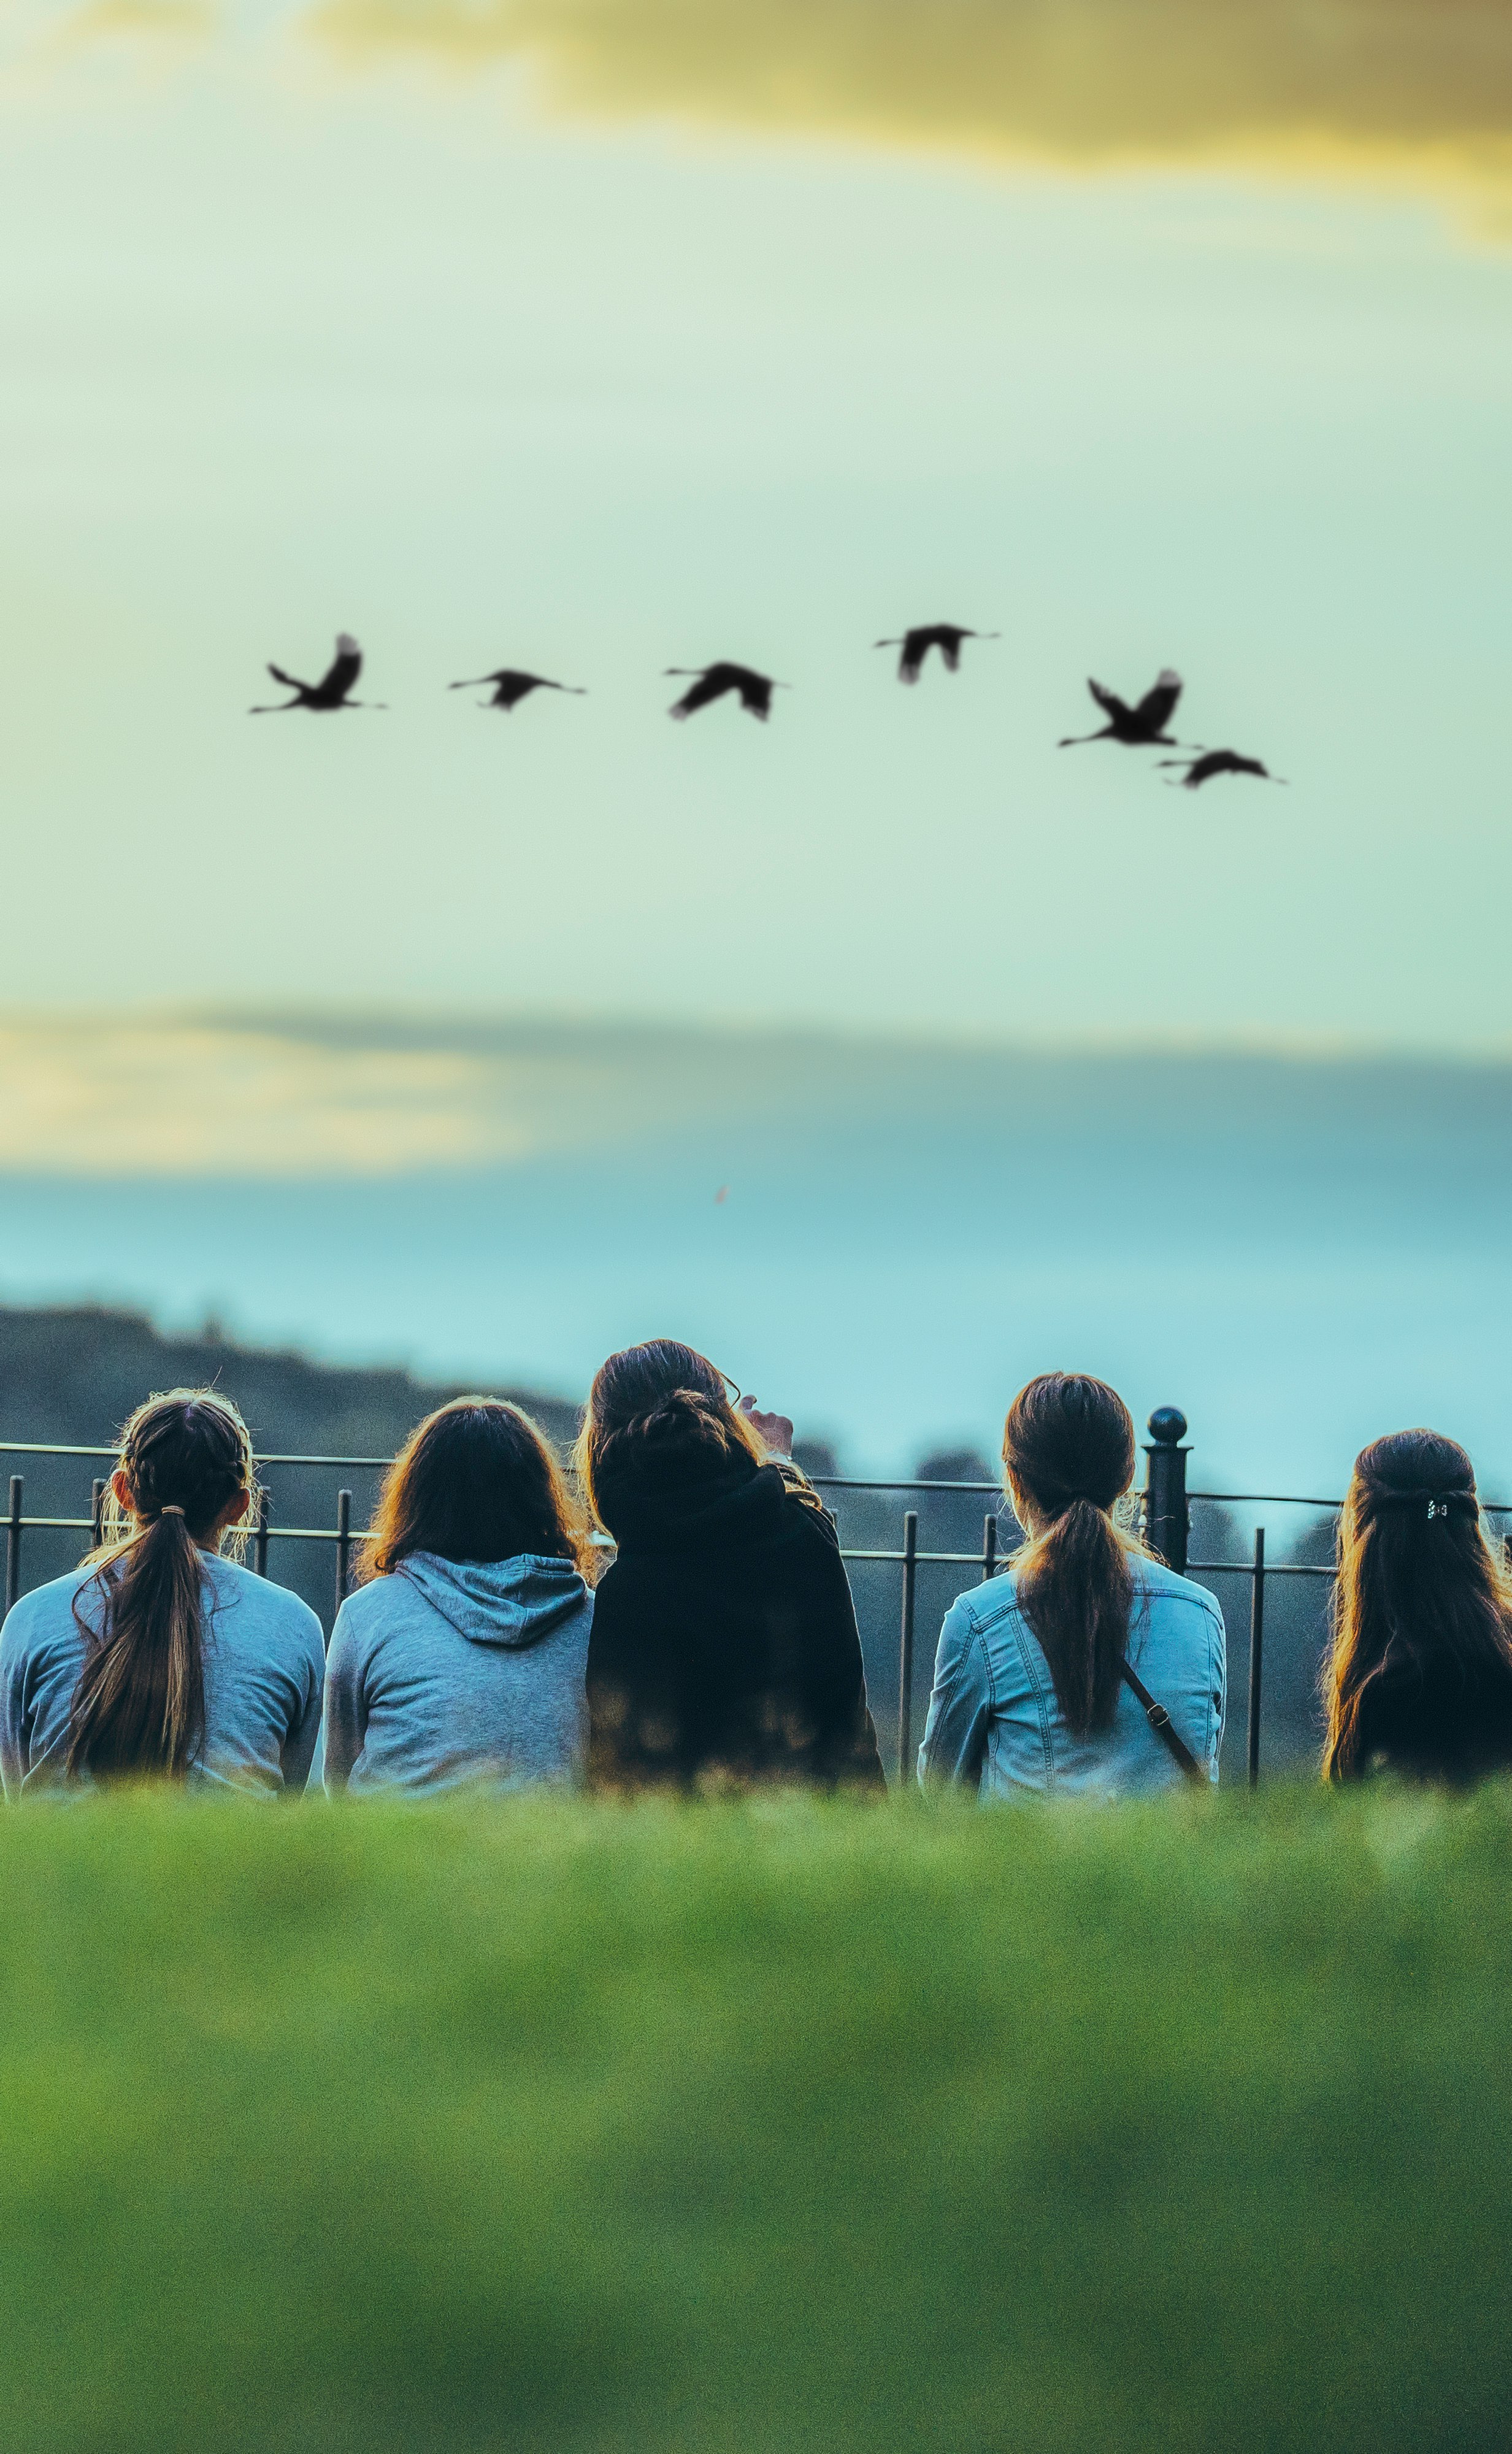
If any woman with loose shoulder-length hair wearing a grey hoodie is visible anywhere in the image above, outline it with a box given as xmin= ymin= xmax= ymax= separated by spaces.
xmin=326 ymin=1396 xmax=594 ymax=1791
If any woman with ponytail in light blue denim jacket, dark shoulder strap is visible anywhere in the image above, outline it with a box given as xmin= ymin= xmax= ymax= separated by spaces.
xmin=918 ymin=1372 xmax=1227 ymax=1799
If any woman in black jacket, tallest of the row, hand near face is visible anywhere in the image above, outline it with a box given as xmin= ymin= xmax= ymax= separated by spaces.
xmin=577 ymin=1337 xmax=884 ymax=1789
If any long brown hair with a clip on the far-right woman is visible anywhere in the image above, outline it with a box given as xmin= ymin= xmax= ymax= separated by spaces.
xmin=1323 ymin=1431 xmax=1512 ymax=1782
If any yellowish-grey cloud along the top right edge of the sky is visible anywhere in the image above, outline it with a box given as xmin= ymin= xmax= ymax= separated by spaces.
xmin=317 ymin=0 xmax=1512 ymax=177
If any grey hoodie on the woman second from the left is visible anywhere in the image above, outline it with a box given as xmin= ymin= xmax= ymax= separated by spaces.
xmin=326 ymin=1551 xmax=594 ymax=1791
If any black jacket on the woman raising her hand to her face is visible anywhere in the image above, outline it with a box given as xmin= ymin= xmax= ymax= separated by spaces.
xmin=589 ymin=1450 xmax=884 ymax=1789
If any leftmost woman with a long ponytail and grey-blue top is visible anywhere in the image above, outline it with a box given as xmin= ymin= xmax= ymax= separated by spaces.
xmin=0 ymin=1389 xmax=326 ymax=1799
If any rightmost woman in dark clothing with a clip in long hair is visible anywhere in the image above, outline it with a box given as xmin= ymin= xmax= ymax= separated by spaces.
xmin=1323 ymin=1431 xmax=1512 ymax=1784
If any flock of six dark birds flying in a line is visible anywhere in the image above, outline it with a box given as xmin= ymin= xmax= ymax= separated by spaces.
xmin=250 ymin=621 xmax=1286 ymax=793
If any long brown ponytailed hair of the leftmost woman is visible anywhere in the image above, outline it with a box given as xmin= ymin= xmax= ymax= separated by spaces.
xmin=66 ymin=1389 xmax=255 ymax=1779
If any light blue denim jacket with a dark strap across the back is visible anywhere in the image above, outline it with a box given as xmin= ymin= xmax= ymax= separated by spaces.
xmin=918 ymin=1558 xmax=1227 ymax=1799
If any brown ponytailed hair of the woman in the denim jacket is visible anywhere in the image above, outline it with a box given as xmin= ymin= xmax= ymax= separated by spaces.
xmin=1004 ymin=1372 xmax=1144 ymax=1737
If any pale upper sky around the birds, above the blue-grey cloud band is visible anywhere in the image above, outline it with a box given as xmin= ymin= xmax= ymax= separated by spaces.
xmin=0 ymin=0 xmax=1512 ymax=1050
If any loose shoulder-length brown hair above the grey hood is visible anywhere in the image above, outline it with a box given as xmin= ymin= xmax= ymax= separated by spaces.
xmin=358 ymin=1396 xmax=594 ymax=1578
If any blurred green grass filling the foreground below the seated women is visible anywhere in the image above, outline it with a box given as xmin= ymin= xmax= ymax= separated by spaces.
xmin=0 ymin=1791 xmax=1512 ymax=2454
